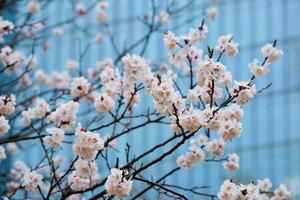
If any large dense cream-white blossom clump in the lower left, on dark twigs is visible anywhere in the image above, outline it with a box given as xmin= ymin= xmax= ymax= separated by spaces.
xmin=73 ymin=127 xmax=104 ymax=161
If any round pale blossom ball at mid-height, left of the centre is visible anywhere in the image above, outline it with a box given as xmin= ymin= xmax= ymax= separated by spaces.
xmin=94 ymin=93 xmax=115 ymax=113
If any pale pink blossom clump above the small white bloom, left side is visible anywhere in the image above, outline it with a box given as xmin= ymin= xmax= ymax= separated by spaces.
xmin=48 ymin=101 xmax=79 ymax=128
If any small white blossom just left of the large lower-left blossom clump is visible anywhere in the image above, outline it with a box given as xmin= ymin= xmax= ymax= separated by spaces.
xmin=43 ymin=128 xmax=65 ymax=148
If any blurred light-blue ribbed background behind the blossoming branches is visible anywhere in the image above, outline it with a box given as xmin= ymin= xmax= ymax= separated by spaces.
xmin=2 ymin=0 xmax=300 ymax=199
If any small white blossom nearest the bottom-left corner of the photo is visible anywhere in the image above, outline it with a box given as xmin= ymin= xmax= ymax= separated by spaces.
xmin=22 ymin=171 xmax=43 ymax=191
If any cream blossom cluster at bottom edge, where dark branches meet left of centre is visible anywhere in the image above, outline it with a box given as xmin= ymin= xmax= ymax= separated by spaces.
xmin=105 ymin=168 xmax=132 ymax=198
